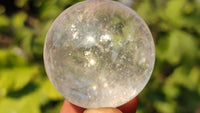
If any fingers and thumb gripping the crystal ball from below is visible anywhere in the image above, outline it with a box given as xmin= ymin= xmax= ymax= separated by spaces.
xmin=60 ymin=97 xmax=138 ymax=113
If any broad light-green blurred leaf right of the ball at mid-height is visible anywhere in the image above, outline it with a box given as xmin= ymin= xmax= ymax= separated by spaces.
xmin=156 ymin=30 xmax=198 ymax=65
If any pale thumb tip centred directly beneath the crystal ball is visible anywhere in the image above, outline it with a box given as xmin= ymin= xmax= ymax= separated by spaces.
xmin=83 ymin=108 xmax=122 ymax=113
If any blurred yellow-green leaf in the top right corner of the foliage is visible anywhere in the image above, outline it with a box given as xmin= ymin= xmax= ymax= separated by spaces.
xmin=160 ymin=0 xmax=200 ymax=31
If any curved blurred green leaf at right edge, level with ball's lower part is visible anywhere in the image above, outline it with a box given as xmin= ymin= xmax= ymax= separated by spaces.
xmin=163 ymin=66 xmax=200 ymax=99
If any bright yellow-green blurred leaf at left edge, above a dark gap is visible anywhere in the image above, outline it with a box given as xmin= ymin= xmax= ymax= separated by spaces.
xmin=0 ymin=66 xmax=38 ymax=92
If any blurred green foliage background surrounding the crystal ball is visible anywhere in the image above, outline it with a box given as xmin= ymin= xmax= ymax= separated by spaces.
xmin=0 ymin=0 xmax=200 ymax=113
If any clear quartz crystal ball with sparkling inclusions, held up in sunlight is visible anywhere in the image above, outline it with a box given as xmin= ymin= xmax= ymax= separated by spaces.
xmin=44 ymin=0 xmax=155 ymax=108
